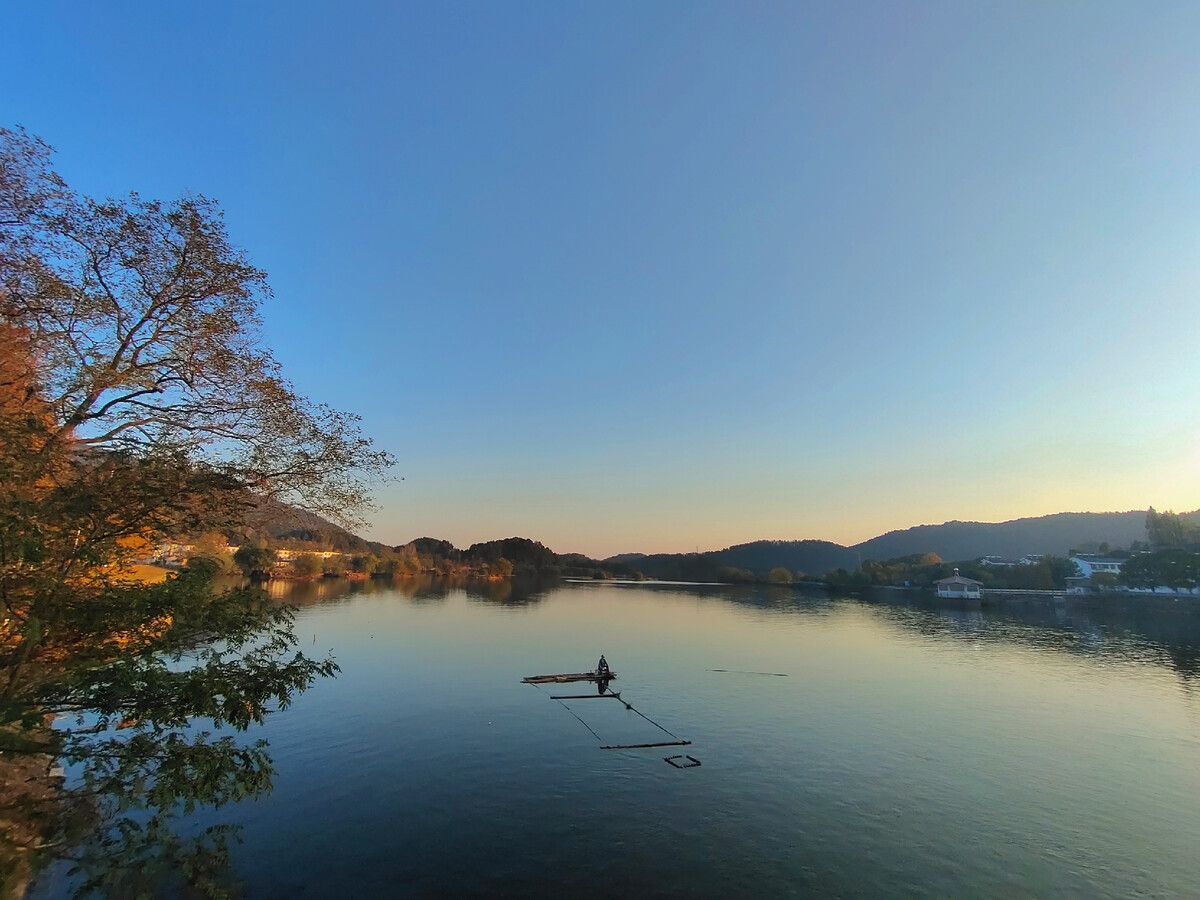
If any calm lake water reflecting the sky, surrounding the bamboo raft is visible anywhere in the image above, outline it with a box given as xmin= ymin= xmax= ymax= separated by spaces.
xmin=37 ymin=583 xmax=1200 ymax=898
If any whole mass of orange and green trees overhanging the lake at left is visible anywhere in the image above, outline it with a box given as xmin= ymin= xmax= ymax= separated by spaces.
xmin=0 ymin=130 xmax=391 ymax=895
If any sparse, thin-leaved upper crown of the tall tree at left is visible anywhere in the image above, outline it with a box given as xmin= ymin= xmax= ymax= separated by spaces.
xmin=0 ymin=125 xmax=390 ymax=522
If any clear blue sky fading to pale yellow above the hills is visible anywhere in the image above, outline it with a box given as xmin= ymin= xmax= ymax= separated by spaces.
xmin=0 ymin=0 xmax=1200 ymax=557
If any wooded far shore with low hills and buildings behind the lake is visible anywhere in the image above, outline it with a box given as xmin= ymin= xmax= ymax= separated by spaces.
xmin=199 ymin=506 xmax=1200 ymax=590
